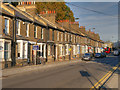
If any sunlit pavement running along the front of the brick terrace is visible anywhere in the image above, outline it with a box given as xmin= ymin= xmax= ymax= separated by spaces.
xmin=0 ymin=60 xmax=81 ymax=78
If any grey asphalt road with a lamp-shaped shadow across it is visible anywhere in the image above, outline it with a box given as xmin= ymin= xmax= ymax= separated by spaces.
xmin=2 ymin=56 xmax=119 ymax=88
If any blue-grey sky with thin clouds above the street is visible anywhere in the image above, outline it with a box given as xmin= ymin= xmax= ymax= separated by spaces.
xmin=66 ymin=0 xmax=118 ymax=42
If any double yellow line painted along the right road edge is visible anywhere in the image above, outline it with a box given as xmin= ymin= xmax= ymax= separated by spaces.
xmin=90 ymin=63 xmax=120 ymax=90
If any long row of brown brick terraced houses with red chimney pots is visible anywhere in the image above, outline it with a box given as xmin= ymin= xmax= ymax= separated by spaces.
xmin=0 ymin=2 xmax=103 ymax=68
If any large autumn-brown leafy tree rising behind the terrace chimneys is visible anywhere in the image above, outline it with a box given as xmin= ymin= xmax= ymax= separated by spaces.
xmin=36 ymin=2 xmax=75 ymax=22
